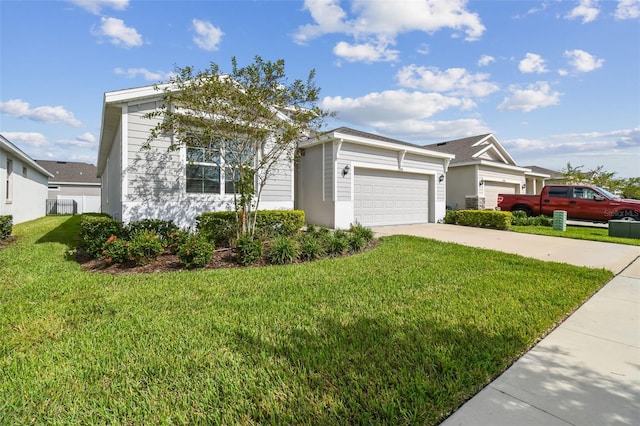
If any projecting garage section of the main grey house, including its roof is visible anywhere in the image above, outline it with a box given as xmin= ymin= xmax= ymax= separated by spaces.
xmin=296 ymin=127 xmax=454 ymax=228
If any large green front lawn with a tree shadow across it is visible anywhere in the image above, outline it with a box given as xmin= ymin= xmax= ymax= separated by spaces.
xmin=0 ymin=216 xmax=612 ymax=425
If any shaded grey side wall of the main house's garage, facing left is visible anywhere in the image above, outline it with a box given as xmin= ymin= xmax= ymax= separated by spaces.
xmin=297 ymin=143 xmax=335 ymax=228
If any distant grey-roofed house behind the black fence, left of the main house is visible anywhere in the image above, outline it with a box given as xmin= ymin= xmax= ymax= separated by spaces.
xmin=36 ymin=160 xmax=101 ymax=213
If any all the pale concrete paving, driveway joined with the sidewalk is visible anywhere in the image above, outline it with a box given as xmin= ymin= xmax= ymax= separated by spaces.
xmin=373 ymin=224 xmax=640 ymax=426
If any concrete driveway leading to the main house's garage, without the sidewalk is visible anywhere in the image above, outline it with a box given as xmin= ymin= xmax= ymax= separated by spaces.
xmin=371 ymin=223 xmax=640 ymax=274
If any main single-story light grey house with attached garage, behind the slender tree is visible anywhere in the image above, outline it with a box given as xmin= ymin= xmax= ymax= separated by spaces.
xmin=97 ymin=86 xmax=454 ymax=228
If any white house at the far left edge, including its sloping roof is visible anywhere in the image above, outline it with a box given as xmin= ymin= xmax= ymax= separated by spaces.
xmin=0 ymin=135 xmax=53 ymax=224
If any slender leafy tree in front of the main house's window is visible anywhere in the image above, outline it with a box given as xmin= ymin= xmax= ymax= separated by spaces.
xmin=146 ymin=56 xmax=331 ymax=234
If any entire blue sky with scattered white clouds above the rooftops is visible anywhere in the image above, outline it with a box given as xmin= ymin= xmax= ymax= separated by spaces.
xmin=0 ymin=0 xmax=640 ymax=177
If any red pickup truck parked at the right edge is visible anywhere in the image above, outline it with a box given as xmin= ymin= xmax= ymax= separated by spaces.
xmin=498 ymin=185 xmax=640 ymax=222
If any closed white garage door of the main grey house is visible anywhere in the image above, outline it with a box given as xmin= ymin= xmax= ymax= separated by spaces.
xmin=354 ymin=168 xmax=429 ymax=226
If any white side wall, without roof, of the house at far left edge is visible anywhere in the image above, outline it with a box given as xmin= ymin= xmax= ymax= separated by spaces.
xmin=0 ymin=150 xmax=48 ymax=224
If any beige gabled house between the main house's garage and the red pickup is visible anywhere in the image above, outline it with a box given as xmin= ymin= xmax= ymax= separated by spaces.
xmin=424 ymin=133 xmax=549 ymax=209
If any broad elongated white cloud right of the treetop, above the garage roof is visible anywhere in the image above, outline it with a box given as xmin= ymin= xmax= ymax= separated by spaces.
xmin=321 ymin=90 xmax=466 ymax=125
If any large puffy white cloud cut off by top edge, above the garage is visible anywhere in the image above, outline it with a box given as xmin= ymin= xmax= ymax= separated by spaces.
xmin=293 ymin=0 xmax=485 ymax=62
